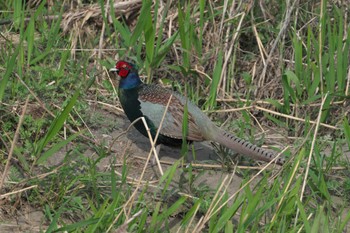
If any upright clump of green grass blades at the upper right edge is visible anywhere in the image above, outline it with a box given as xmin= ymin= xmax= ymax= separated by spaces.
xmin=282 ymin=7 xmax=350 ymax=116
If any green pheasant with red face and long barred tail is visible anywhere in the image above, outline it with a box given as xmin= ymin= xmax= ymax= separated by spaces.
xmin=110 ymin=61 xmax=285 ymax=165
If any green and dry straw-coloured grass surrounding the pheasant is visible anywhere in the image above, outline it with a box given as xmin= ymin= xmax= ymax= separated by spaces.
xmin=0 ymin=0 xmax=350 ymax=232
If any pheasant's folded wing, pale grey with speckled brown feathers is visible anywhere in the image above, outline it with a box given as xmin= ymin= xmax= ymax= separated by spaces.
xmin=138 ymin=85 xmax=205 ymax=141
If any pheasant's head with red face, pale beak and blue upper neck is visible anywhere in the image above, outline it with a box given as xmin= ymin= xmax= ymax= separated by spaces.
xmin=109 ymin=61 xmax=142 ymax=89
